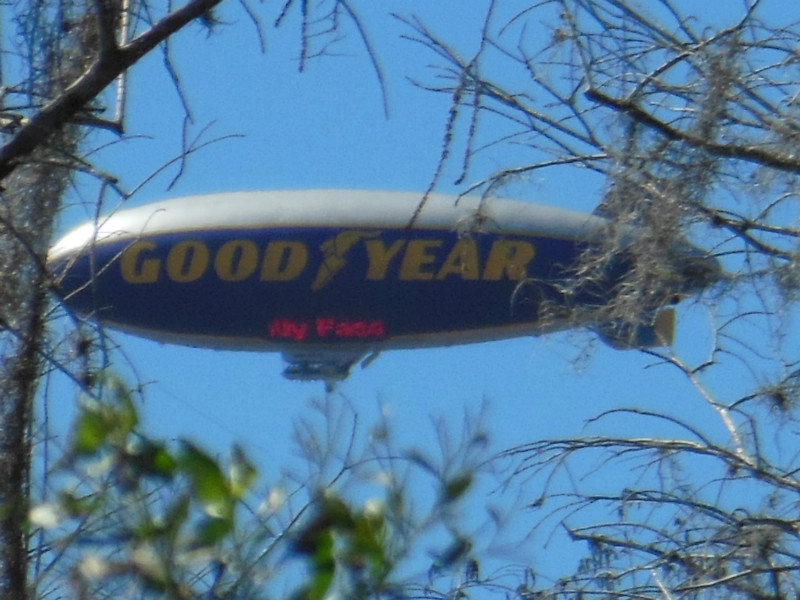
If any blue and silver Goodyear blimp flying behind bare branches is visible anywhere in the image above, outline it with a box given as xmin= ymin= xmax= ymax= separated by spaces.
xmin=48 ymin=190 xmax=719 ymax=382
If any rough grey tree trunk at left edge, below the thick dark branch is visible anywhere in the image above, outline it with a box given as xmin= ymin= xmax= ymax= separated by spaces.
xmin=0 ymin=148 xmax=77 ymax=600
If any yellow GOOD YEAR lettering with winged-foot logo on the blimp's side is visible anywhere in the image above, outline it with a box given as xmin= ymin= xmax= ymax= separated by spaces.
xmin=120 ymin=231 xmax=536 ymax=291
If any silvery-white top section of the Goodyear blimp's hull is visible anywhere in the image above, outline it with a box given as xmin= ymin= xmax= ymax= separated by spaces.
xmin=49 ymin=190 xmax=606 ymax=260
